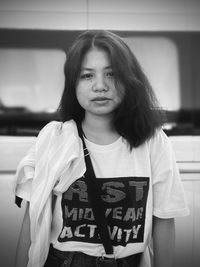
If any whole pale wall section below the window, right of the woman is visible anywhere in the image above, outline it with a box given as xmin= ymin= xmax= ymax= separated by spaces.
xmin=170 ymin=136 xmax=200 ymax=267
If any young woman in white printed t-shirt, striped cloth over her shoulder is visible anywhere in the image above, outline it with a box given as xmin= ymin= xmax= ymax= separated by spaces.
xmin=15 ymin=31 xmax=188 ymax=267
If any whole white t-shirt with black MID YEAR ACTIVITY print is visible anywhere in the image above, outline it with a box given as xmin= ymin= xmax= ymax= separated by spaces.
xmin=51 ymin=131 xmax=187 ymax=258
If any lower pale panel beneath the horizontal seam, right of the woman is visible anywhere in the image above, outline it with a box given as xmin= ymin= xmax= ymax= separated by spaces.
xmin=174 ymin=173 xmax=200 ymax=267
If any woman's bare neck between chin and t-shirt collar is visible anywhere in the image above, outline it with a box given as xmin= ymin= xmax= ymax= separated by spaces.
xmin=82 ymin=116 xmax=119 ymax=145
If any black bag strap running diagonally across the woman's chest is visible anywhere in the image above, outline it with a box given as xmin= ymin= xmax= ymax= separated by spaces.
xmin=77 ymin=125 xmax=113 ymax=254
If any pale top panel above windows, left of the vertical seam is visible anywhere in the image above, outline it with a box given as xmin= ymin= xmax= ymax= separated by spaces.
xmin=0 ymin=0 xmax=87 ymax=30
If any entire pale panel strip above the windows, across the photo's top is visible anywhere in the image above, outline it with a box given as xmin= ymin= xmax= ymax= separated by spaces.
xmin=0 ymin=0 xmax=200 ymax=31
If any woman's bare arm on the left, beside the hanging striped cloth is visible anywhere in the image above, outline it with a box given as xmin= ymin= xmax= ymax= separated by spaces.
xmin=15 ymin=203 xmax=31 ymax=267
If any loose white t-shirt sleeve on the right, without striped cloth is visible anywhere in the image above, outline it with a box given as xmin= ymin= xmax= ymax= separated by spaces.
xmin=150 ymin=130 xmax=189 ymax=218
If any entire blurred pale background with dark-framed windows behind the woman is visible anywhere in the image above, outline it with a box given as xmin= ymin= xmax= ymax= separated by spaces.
xmin=0 ymin=0 xmax=200 ymax=267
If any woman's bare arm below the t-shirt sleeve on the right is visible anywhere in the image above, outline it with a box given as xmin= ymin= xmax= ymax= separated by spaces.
xmin=153 ymin=217 xmax=175 ymax=267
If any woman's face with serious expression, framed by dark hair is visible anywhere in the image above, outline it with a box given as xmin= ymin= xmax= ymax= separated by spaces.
xmin=76 ymin=48 xmax=124 ymax=121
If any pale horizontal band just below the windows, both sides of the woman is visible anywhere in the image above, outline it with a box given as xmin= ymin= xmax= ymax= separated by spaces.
xmin=0 ymin=136 xmax=200 ymax=174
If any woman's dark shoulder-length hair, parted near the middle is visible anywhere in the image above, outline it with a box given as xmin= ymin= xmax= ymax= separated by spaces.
xmin=59 ymin=30 xmax=163 ymax=151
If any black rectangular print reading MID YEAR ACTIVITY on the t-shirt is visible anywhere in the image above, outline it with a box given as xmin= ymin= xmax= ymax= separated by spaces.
xmin=58 ymin=177 xmax=149 ymax=246
